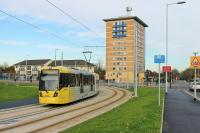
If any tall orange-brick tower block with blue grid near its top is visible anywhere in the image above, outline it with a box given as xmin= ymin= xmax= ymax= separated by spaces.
xmin=104 ymin=16 xmax=148 ymax=83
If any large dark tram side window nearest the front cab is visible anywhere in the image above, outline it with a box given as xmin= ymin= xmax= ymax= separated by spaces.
xmin=60 ymin=73 xmax=76 ymax=87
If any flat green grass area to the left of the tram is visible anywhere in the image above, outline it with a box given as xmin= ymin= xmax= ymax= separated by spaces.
xmin=0 ymin=83 xmax=38 ymax=103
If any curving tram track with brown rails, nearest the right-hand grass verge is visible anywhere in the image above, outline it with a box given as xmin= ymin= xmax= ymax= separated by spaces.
xmin=0 ymin=89 xmax=131 ymax=132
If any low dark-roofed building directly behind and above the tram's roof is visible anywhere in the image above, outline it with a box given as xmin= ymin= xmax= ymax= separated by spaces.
xmin=49 ymin=60 xmax=95 ymax=73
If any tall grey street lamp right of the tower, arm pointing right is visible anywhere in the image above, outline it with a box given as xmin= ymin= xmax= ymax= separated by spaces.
xmin=165 ymin=1 xmax=186 ymax=93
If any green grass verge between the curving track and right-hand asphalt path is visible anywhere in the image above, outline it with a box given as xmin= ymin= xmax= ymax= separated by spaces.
xmin=62 ymin=88 xmax=164 ymax=133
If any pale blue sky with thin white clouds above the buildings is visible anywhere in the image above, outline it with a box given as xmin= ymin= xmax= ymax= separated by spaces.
xmin=0 ymin=0 xmax=200 ymax=71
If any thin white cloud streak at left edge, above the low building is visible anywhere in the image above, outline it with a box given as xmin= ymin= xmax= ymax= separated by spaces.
xmin=0 ymin=40 xmax=30 ymax=46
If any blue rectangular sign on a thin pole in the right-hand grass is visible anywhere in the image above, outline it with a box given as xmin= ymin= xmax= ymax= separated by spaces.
xmin=154 ymin=55 xmax=165 ymax=106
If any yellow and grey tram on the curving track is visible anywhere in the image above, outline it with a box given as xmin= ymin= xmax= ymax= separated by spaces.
xmin=39 ymin=66 xmax=97 ymax=104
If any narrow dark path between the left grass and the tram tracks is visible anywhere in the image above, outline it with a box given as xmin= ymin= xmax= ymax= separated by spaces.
xmin=0 ymin=98 xmax=39 ymax=109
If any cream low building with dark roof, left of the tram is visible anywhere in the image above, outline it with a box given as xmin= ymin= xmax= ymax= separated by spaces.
xmin=14 ymin=59 xmax=52 ymax=80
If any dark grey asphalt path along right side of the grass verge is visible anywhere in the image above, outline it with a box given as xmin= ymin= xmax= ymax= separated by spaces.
xmin=163 ymin=81 xmax=200 ymax=133
